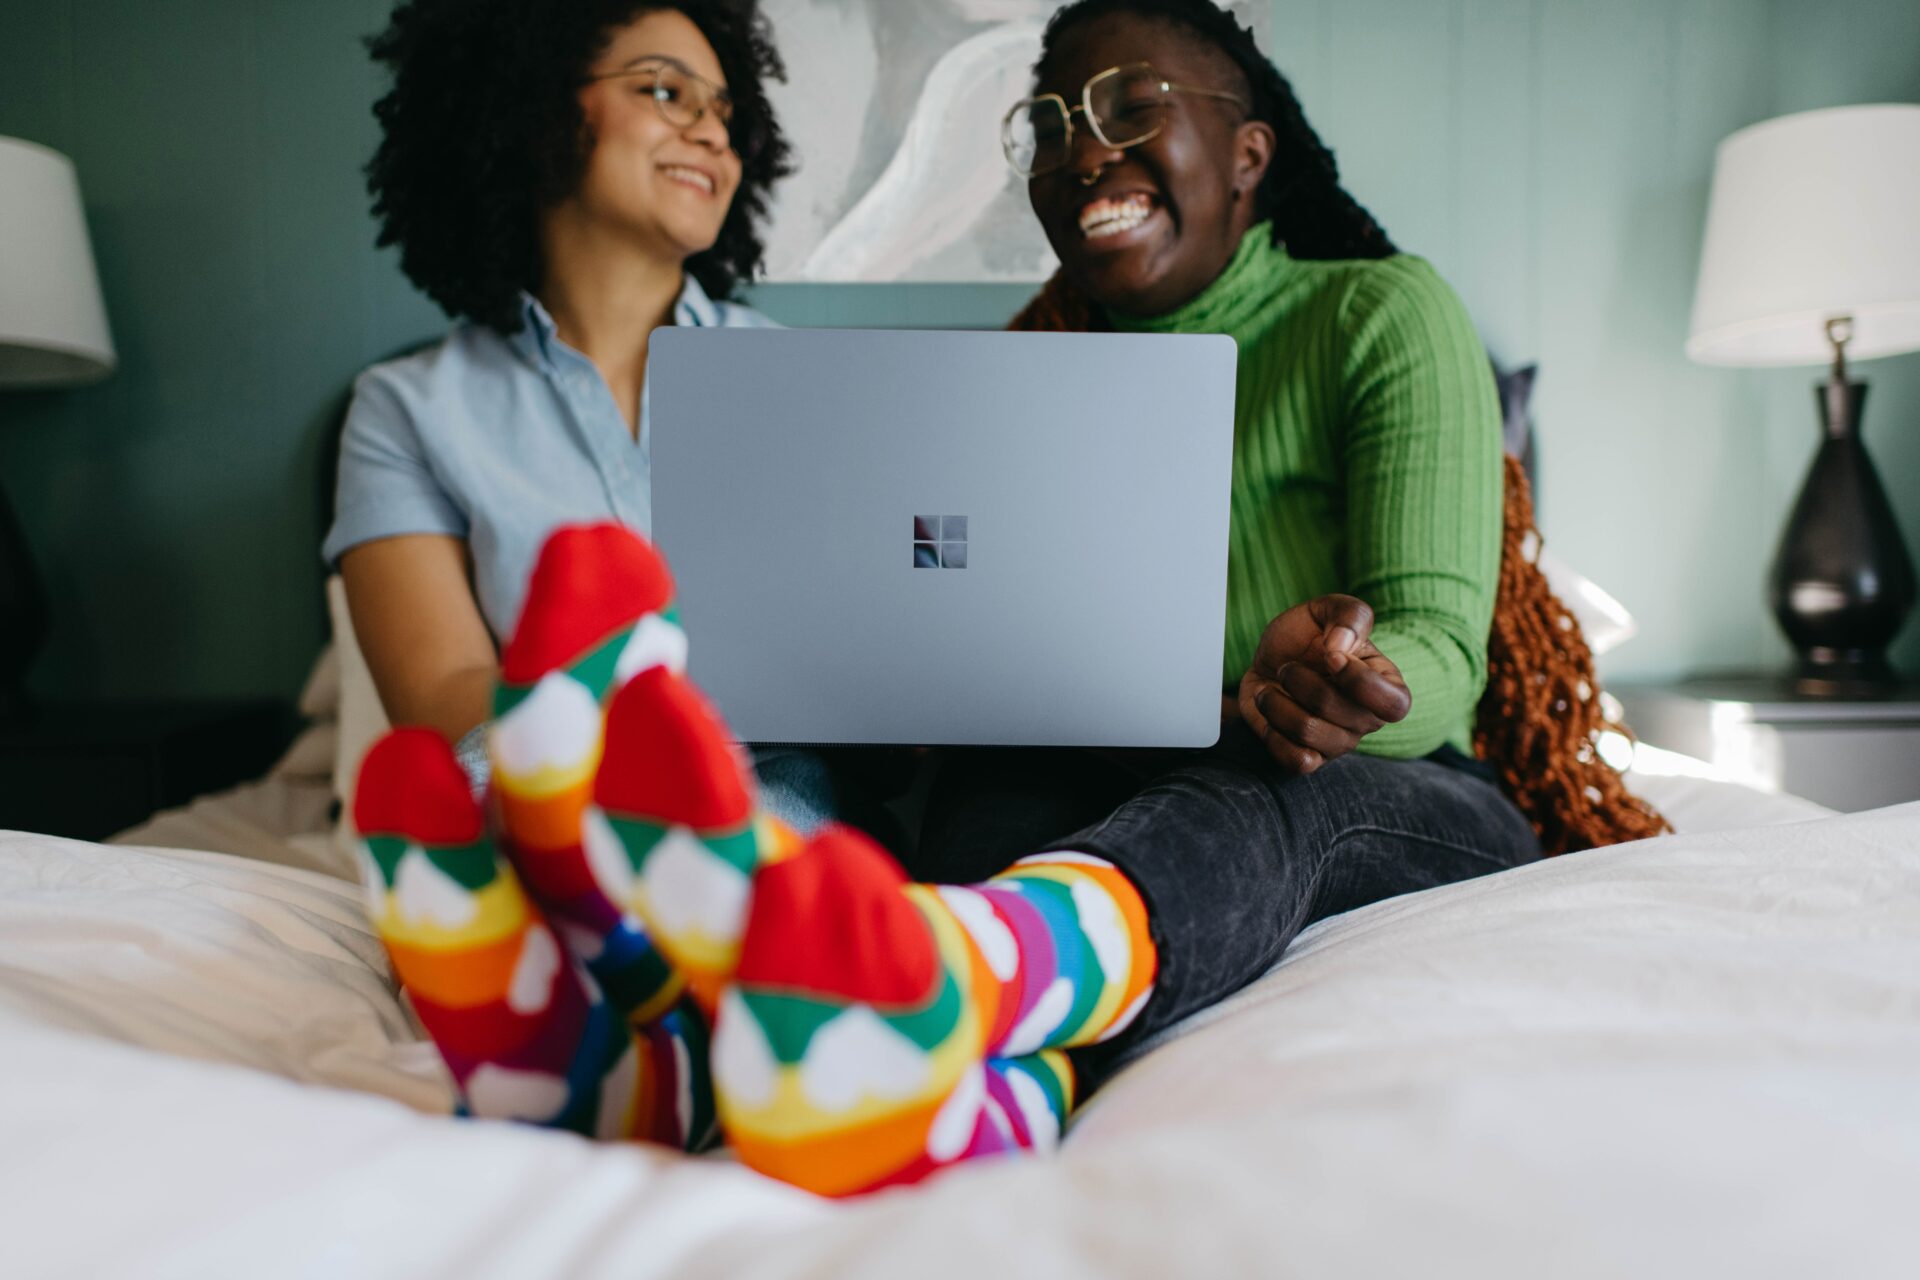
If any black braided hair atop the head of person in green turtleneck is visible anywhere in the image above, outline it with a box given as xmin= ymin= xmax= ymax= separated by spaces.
xmin=1035 ymin=0 xmax=1398 ymax=259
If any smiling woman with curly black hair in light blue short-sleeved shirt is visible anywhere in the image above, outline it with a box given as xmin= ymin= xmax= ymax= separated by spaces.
xmin=324 ymin=0 xmax=801 ymax=793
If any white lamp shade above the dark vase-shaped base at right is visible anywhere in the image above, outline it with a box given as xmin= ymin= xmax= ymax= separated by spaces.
xmin=1686 ymin=104 xmax=1920 ymax=365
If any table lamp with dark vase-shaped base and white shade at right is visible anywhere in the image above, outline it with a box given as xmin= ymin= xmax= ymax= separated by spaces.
xmin=1686 ymin=104 xmax=1920 ymax=697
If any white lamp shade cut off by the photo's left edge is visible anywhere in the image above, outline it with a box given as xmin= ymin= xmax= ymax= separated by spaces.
xmin=0 ymin=138 xmax=113 ymax=386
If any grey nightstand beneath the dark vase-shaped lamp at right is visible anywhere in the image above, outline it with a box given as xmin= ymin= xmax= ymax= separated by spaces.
xmin=1607 ymin=676 xmax=1920 ymax=812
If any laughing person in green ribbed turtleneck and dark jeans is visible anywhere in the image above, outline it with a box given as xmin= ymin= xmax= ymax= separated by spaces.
xmin=906 ymin=0 xmax=1540 ymax=1082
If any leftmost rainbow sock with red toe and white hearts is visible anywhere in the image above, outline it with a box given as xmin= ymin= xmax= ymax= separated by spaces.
xmin=353 ymin=729 xmax=712 ymax=1148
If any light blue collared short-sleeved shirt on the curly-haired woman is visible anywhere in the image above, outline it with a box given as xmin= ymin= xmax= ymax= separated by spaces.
xmin=321 ymin=276 xmax=774 ymax=643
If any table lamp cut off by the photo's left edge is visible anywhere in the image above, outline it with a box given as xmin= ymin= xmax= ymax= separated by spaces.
xmin=0 ymin=138 xmax=113 ymax=720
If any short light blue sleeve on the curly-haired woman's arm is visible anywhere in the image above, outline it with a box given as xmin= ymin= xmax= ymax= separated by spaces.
xmin=321 ymin=368 xmax=468 ymax=566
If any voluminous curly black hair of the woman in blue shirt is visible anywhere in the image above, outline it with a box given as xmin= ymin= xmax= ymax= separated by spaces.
xmin=367 ymin=0 xmax=793 ymax=334
